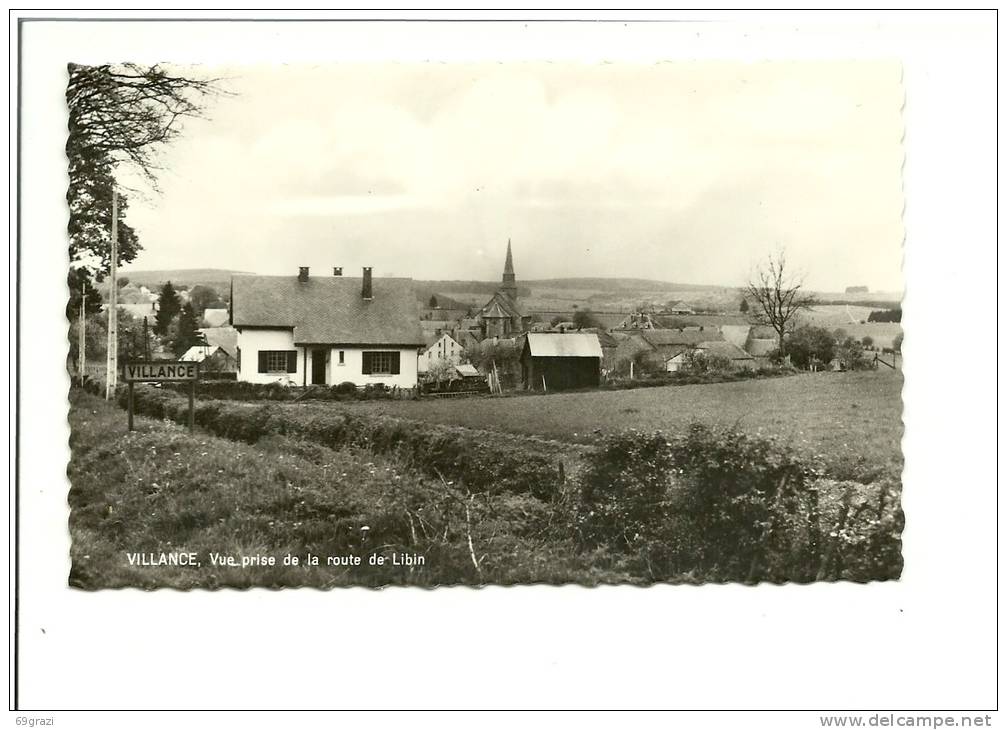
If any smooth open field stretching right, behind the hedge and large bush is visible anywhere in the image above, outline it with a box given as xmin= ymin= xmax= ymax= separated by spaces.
xmin=294 ymin=371 xmax=902 ymax=478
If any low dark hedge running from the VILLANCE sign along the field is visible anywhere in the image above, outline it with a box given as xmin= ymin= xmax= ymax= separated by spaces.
xmin=119 ymin=388 xmax=583 ymax=499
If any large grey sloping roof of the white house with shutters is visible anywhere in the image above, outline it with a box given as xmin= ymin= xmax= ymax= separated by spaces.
xmin=231 ymin=276 xmax=424 ymax=345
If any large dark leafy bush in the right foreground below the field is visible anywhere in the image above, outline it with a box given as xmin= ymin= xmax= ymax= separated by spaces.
xmin=572 ymin=424 xmax=902 ymax=582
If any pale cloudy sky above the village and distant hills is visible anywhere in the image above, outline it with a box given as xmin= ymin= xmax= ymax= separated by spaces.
xmin=115 ymin=61 xmax=903 ymax=291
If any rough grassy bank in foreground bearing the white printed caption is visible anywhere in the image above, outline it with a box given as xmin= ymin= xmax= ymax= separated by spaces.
xmin=67 ymin=391 xmax=612 ymax=590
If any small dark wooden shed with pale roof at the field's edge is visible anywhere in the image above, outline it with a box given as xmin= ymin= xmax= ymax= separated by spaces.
xmin=521 ymin=332 xmax=602 ymax=391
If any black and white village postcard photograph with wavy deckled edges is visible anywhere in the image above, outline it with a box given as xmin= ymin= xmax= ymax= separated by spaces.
xmin=66 ymin=61 xmax=903 ymax=590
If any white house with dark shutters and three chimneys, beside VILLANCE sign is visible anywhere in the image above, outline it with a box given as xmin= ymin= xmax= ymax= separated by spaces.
xmin=231 ymin=267 xmax=424 ymax=388
